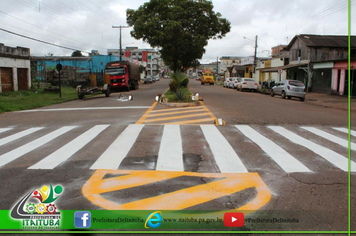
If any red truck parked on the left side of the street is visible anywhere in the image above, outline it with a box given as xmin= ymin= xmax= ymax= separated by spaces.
xmin=105 ymin=61 xmax=140 ymax=91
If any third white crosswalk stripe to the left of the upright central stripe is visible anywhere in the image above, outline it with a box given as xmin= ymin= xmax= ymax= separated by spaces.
xmin=0 ymin=126 xmax=76 ymax=167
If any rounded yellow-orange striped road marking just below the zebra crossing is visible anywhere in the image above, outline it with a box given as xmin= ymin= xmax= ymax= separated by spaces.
xmin=82 ymin=170 xmax=272 ymax=213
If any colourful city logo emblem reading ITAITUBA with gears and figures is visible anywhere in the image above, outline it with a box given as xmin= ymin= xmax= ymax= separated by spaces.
xmin=11 ymin=184 xmax=63 ymax=229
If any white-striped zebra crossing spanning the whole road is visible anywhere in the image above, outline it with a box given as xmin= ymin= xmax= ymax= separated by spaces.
xmin=0 ymin=124 xmax=356 ymax=173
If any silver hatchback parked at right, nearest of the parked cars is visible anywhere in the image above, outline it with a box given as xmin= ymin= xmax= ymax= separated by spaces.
xmin=271 ymin=80 xmax=305 ymax=102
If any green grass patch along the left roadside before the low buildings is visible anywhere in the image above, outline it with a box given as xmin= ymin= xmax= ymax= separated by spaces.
xmin=0 ymin=87 xmax=78 ymax=113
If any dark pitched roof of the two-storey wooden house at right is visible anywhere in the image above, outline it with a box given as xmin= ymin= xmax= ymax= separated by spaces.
xmin=286 ymin=34 xmax=356 ymax=50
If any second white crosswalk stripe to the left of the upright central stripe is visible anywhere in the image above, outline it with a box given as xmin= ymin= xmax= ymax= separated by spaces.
xmin=28 ymin=125 xmax=109 ymax=170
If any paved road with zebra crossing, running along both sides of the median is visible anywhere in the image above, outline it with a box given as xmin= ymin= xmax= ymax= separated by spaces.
xmin=0 ymin=80 xmax=356 ymax=230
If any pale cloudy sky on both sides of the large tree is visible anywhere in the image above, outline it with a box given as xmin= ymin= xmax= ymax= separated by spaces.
xmin=0 ymin=0 xmax=356 ymax=63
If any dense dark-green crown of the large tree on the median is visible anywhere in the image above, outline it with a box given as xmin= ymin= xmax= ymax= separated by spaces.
xmin=126 ymin=0 xmax=230 ymax=71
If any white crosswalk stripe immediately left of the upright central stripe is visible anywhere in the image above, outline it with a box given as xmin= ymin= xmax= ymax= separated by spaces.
xmin=90 ymin=125 xmax=144 ymax=169
